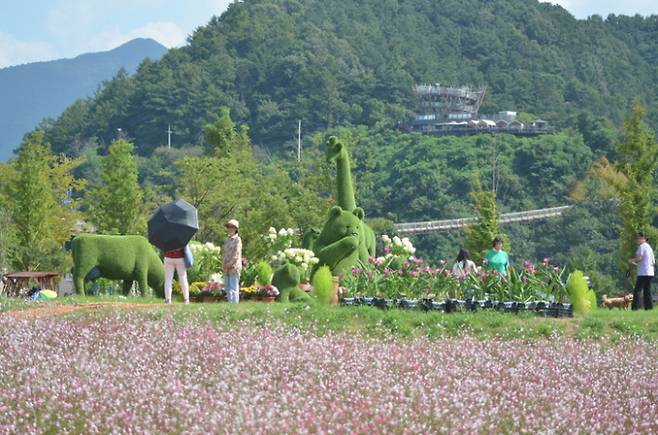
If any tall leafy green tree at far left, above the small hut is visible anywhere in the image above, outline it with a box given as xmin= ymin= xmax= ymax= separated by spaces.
xmin=0 ymin=131 xmax=83 ymax=270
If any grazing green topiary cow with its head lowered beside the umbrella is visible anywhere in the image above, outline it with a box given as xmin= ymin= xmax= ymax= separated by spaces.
xmin=72 ymin=234 xmax=164 ymax=297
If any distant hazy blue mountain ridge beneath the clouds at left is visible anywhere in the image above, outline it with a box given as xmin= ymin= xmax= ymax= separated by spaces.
xmin=0 ymin=39 xmax=167 ymax=161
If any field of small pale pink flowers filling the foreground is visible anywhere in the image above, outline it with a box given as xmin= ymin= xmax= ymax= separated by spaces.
xmin=0 ymin=313 xmax=658 ymax=434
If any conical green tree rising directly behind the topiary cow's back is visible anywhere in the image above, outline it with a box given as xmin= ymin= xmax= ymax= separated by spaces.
xmin=86 ymin=139 xmax=144 ymax=234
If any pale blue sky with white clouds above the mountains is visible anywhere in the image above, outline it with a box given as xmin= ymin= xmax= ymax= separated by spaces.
xmin=0 ymin=0 xmax=658 ymax=68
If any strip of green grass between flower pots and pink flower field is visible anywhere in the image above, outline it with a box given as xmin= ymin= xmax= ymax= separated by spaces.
xmin=0 ymin=296 xmax=658 ymax=341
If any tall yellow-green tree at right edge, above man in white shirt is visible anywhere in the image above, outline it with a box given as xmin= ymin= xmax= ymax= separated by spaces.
xmin=594 ymin=102 xmax=658 ymax=268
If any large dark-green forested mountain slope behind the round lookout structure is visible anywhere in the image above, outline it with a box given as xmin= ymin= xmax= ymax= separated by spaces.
xmin=43 ymin=0 xmax=658 ymax=155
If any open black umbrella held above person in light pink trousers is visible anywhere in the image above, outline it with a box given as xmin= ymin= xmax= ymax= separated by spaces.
xmin=148 ymin=199 xmax=199 ymax=252
